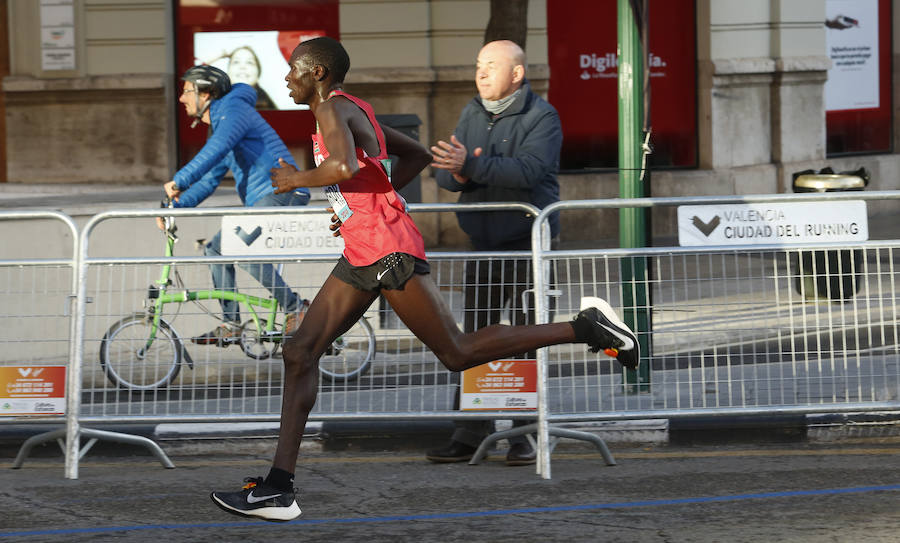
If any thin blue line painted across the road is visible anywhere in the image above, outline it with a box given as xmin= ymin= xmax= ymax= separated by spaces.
xmin=7 ymin=484 xmax=900 ymax=538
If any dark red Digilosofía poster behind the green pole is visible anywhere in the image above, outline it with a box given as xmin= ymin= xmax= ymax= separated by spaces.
xmin=547 ymin=0 xmax=697 ymax=169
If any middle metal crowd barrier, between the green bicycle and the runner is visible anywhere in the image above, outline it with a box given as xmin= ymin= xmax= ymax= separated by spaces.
xmin=59 ymin=204 xmax=539 ymax=478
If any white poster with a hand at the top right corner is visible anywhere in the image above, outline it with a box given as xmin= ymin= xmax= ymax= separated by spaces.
xmin=825 ymin=0 xmax=880 ymax=111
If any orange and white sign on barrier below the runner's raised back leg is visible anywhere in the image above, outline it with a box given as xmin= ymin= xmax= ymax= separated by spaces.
xmin=459 ymin=360 xmax=537 ymax=411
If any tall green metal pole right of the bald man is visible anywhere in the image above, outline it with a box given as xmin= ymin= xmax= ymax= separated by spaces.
xmin=617 ymin=0 xmax=650 ymax=390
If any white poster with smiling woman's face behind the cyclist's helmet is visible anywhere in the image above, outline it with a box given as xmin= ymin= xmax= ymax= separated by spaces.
xmin=194 ymin=30 xmax=325 ymax=109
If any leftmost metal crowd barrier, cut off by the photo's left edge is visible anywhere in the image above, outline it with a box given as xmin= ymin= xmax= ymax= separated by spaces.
xmin=0 ymin=211 xmax=94 ymax=472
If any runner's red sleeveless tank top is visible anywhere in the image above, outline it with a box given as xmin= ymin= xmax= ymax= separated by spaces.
xmin=312 ymin=91 xmax=425 ymax=266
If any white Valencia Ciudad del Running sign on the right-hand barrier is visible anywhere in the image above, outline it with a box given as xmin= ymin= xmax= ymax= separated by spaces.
xmin=678 ymin=200 xmax=869 ymax=246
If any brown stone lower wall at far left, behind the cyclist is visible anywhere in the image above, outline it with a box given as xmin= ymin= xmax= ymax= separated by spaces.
xmin=3 ymin=75 xmax=174 ymax=184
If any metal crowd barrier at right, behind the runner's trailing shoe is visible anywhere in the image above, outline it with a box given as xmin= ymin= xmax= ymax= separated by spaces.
xmin=533 ymin=192 xmax=900 ymax=477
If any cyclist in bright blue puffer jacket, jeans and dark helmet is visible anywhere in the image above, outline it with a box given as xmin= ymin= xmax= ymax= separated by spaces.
xmin=164 ymin=65 xmax=309 ymax=347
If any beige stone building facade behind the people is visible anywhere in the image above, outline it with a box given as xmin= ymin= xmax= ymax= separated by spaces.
xmin=0 ymin=0 xmax=900 ymax=245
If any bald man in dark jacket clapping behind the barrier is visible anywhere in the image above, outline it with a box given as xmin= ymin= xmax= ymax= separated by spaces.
xmin=426 ymin=40 xmax=562 ymax=466
